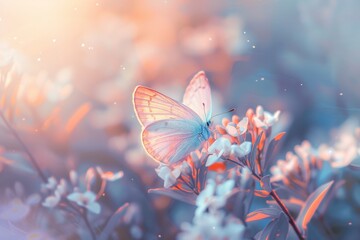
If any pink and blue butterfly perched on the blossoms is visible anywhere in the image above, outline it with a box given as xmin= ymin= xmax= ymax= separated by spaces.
xmin=133 ymin=71 xmax=212 ymax=165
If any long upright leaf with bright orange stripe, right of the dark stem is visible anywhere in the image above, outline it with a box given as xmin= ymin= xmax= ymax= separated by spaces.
xmin=296 ymin=181 xmax=334 ymax=231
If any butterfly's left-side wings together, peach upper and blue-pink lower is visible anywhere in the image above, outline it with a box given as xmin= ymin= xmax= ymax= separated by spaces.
xmin=133 ymin=86 xmax=208 ymax=164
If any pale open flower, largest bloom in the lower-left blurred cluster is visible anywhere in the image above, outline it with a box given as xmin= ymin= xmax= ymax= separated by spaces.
xmin=67 ymin=191 xmax=101 ymax=214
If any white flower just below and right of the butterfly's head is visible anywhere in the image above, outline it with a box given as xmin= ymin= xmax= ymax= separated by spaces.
xmin=206 ymin=137 xmax=231 ymax=167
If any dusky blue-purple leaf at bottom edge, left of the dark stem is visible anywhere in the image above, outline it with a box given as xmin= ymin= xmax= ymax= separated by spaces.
xmin=255 ymin=212 xmax=289 ymax=240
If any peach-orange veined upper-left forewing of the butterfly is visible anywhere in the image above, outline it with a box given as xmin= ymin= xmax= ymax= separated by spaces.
xmin=133 ymin=86 xmax=202 ymax=127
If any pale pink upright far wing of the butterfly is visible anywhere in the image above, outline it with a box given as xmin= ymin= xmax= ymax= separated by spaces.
xmin=183 ymin=71 xmax=212 ymax=122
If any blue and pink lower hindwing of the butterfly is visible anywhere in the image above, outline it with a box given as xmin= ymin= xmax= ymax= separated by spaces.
xmin=142 ymin=119 xmax=206 ymax=164
